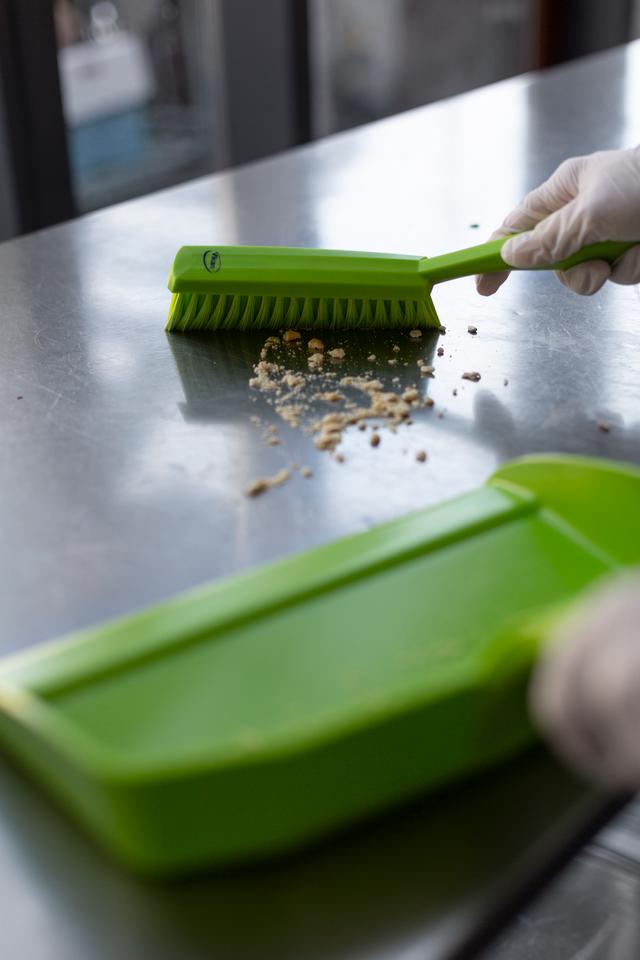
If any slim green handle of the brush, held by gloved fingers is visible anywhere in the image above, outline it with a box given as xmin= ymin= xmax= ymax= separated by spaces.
xmin=418 ymin=236 xmax=638 ymax=283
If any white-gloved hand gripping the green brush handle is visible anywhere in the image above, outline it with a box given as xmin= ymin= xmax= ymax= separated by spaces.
xmin=476 ymin=147 xmax=640 ymax=297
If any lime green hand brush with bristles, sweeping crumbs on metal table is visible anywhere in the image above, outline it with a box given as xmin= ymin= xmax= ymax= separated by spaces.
xmin=166 ymin=237 xmax=634 ymax=332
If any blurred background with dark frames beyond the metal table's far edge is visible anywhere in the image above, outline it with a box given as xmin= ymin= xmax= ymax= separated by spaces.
xmin=0 ymin=0 xmax=640 ymax=240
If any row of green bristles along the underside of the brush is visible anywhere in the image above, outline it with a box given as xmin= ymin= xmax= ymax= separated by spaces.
xmin=165 ymin=293 xmax=440 ymax=333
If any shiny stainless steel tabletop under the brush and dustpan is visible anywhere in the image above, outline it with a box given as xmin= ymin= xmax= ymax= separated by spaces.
xmin=0 ymin=45 xmax=640 ymax=960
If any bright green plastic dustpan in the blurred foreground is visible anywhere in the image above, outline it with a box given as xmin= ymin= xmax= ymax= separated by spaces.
xmin=0 ymin=457 xmax=640 ymax=874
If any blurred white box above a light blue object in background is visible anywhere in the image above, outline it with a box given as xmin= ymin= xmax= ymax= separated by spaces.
xmin=58 ymin=31 xmax=155 ymax=127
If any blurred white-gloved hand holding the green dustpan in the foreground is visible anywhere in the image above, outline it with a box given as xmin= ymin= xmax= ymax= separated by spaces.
xmin=530 ymin=573 xmax=640 ymax=789
